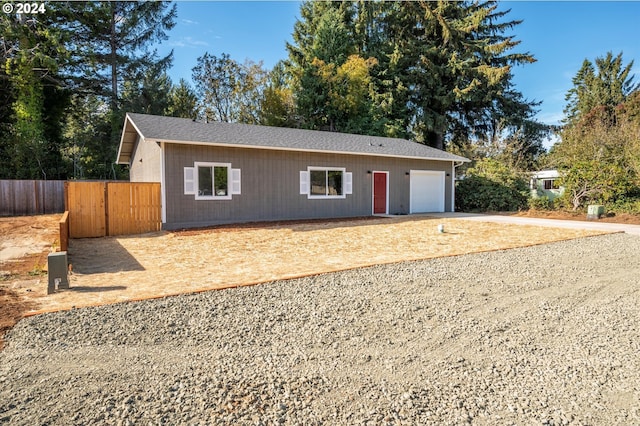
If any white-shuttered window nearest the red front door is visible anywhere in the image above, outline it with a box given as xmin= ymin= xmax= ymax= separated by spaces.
xmin=300 ymin=167 xmax=352 ymax=198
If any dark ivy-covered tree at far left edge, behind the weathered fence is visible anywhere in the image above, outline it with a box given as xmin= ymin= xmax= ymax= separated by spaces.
xmin=0 ymin=5 xmax=68 ymax=179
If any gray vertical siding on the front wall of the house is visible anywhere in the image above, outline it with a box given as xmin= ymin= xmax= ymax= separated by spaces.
xmin=165 ymin=143 xmax=452 ymax=229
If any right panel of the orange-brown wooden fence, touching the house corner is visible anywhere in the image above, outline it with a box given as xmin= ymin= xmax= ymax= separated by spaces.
xmin=107 ymin=182 xmax=162 ymax=235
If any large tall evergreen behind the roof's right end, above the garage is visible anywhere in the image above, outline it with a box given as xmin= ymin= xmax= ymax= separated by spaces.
xmin=401 ymin=0 xmax=534 ymax=148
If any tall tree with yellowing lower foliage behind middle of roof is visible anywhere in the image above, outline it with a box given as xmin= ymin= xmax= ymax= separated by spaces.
xmin=288 ymin=2 xmax=383 ymax=134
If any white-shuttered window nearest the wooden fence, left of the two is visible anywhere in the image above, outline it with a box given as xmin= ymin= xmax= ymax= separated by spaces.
xmin=184 ymin=161 xmax=240 ymax=200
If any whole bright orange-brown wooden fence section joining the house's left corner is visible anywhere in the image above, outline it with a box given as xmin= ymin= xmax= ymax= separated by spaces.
xmin=65 ymin=181 xmax=162 ymax=238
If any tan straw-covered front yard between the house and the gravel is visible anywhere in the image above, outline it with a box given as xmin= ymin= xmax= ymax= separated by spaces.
xmin=1 ymin=217 xmax=616 ymax=313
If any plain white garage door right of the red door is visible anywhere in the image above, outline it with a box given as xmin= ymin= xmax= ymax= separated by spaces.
xmin=409 ymin=170 xmax=444 ymax=213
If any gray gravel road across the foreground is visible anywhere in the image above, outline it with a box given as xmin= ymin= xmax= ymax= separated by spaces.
xmin=0 ymin=234 xmax=640 ymax=425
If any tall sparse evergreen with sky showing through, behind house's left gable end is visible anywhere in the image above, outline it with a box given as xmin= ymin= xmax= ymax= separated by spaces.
xmin=64 ymin=1 xmax=177 ymax=178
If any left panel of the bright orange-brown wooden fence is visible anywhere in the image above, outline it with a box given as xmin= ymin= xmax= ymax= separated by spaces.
xmin=65 ymin=181 xmax=107 ymax=238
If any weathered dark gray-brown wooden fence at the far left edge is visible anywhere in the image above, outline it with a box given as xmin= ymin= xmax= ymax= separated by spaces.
xmin=0 ymin=180 xmax=64 ymax=216
